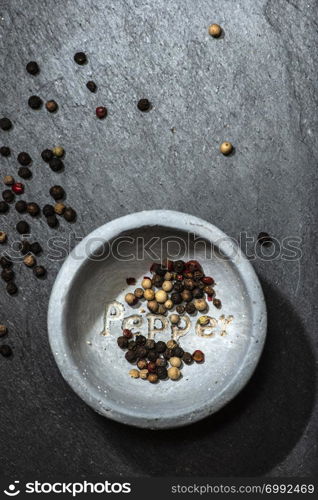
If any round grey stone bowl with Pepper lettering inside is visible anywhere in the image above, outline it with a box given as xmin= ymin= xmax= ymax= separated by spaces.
xmin=48 ymin=210 xmax=266 ymax=429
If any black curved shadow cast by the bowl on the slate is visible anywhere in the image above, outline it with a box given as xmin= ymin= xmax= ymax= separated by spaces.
xmin=94 ymin=282 xmax=316 ymax=477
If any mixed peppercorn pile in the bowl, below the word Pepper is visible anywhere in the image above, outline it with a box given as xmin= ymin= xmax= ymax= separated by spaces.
xmin=117 ymin=329 xmax=204 ymax=384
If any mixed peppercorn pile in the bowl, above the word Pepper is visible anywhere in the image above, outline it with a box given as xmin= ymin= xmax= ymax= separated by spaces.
xmin=125 ymin=260 xmax=221 ymax=316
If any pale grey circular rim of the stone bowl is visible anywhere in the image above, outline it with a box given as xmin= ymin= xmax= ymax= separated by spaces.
xmin=47 ymin=210 xmax=267 ymax=429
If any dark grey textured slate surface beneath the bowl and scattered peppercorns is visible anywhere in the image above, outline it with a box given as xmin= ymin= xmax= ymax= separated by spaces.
xmin=0 ymin=0 xmax=318 ymax=477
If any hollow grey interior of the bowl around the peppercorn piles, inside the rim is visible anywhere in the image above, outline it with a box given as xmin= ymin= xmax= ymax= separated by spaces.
xmin=64 ymin=225 xmax=254 ymax=421
